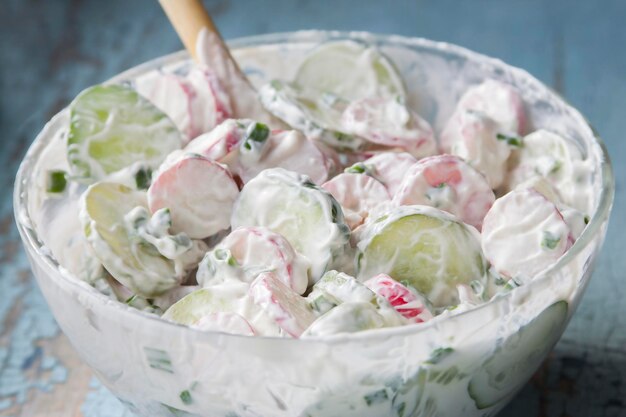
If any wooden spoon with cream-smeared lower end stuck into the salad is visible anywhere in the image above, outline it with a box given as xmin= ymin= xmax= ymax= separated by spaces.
xmin=159 ymin=0 xmax=284 ymax=124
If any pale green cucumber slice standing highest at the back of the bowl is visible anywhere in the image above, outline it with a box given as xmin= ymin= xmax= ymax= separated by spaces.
xmin=294 ymin=41 xmax=406 ymax=100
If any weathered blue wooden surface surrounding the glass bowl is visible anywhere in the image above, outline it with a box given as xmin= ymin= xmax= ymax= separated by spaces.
xmin=0 ymin=0 xmax=626 ymax=417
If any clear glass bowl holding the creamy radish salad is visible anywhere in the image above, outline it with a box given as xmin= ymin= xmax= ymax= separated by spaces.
xmin=14 ymin=31 xmax=614 ymax=417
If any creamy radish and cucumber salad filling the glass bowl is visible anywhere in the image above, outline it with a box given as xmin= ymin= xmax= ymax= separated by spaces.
xmin=37 ymin=41 xmax=591 ymax=338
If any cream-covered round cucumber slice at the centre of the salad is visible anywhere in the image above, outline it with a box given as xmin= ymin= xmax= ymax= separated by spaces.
xmin=231 ymin=168 xmax=350 ymax=284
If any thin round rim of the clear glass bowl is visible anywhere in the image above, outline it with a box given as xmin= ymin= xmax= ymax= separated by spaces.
xmin=13 ymin=30 xmax=615 ymax=344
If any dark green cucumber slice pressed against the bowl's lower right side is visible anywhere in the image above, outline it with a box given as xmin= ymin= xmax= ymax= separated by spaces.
xmin=467 ymin=301 xmax=568 ymax=410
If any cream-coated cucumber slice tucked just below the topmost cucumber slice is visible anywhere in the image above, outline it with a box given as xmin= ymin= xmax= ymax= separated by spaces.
xmin=259 ymin=80 xmax=363 ymax=150
